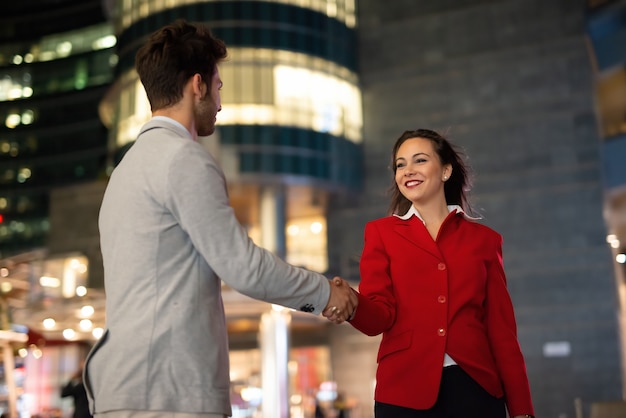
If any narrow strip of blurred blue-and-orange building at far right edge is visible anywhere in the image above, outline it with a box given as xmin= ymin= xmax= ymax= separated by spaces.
xmin=585 ymin=1 xmax=626 ymax=396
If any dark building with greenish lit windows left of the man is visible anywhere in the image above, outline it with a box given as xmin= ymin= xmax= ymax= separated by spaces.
xmin=0 ymin=0 xmax=115 ymax=257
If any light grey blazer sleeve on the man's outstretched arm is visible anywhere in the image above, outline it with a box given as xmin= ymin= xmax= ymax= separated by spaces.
xmin=166 ymin=143 xmax=330 ymax=314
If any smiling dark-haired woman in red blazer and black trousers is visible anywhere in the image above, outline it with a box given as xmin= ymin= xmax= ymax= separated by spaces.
xmin=350 ymin=129 xmax=534 ymax=418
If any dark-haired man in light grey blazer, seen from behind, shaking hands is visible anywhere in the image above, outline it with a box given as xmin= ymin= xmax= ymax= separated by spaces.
xmin=85 ymin=21 xmax=357 ymax=418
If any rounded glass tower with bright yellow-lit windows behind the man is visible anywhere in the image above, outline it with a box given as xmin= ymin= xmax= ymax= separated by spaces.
xmin=101 ymin=0 xmax=362 ymax=272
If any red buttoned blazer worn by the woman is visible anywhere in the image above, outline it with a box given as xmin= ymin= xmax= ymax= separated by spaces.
xmin=350 ymin=211 xmax=534 ymax=416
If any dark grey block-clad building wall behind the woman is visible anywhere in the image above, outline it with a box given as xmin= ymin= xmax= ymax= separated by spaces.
xmin=329 ymin=0 xmax=622 ymax=418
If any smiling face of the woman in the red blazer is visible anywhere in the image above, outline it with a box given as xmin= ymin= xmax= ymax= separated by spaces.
xmin=394 ymin=138 xmax=452 ymax=207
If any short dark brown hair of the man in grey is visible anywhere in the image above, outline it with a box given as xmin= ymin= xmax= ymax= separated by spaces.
xmin=135 ymin=19 xmax=227 ymax=111
